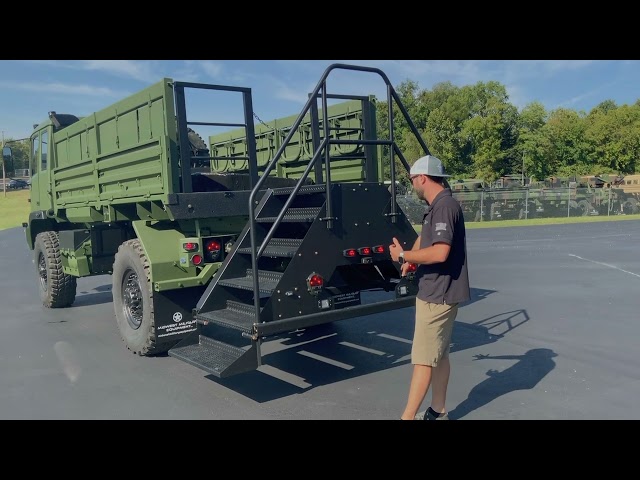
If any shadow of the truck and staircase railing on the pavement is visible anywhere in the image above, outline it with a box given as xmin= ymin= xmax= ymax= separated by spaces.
xmin=212 ymin=300 xmax=528 ymax=403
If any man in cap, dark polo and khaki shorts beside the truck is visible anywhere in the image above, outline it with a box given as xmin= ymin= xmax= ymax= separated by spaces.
xmin=389 ymin=155 xmax=470 ymax=420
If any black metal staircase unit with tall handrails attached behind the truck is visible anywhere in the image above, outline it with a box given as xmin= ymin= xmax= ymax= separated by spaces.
xmin=168 ymin=65 xmax=428 ymax=378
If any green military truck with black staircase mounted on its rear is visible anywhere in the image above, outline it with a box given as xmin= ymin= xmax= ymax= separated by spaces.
xmin=17 ymin=64 xmax=429 ymax=378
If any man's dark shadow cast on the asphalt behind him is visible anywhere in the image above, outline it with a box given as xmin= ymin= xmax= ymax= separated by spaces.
xmin=449 ymin=348 xmax=557 ymax=420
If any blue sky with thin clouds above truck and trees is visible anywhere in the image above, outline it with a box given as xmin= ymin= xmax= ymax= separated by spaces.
xmin=0 ymin=60 xmax=640 ymax=139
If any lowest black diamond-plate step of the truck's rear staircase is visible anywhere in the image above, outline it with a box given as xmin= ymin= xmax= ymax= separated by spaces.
xmin=168 ymin=335 xmax=259 ymax=378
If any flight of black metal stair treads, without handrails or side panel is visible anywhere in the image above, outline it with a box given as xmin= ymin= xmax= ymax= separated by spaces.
xmin=169 ymin=185 xmax=326 ymax=378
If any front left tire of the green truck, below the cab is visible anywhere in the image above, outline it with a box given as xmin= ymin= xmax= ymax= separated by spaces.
xmin=33 ymin=232 xmax=77 ymax=308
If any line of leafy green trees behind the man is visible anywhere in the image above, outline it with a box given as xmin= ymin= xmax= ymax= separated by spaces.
xmin=377 ymin=80 xmax=640 ymax=182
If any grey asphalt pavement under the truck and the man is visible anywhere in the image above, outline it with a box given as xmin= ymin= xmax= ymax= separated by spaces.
xmin=0 ymin=220 xmax=640 ymax=420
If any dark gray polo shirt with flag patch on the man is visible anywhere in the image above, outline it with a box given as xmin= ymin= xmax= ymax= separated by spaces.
xmin=416 ymin=188 xmax=471 ymax=305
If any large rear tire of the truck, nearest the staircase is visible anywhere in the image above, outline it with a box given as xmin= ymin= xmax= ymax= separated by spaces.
xmin=111 ymin=240 xmax=161 ymax=356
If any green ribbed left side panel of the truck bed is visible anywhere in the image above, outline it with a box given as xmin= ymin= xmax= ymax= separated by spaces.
xmin=53 ymin=79 xmax=179 ymax=212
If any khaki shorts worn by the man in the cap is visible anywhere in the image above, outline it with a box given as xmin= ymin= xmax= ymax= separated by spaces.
xmin=411 ymin=298 xmax=458 ymax=367
